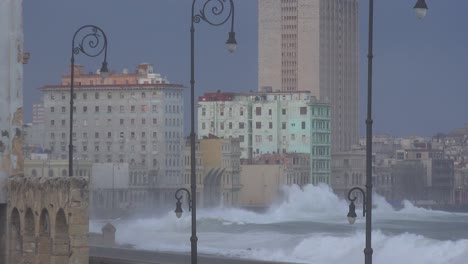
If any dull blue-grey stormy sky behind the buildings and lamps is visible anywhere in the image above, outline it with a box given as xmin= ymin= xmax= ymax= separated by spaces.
xmin=23 ymin=0 xmax=468 ymax=136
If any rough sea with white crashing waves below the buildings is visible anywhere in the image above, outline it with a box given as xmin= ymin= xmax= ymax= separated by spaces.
xmin=90 ymin=185 xmax=468 ymax=264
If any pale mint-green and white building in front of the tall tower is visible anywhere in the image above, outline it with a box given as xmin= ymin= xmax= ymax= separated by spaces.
xmin=198 ymin=92 xmax=331 ymax=184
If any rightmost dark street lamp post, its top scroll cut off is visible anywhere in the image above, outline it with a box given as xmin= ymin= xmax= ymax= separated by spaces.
xmin=348 ymin=0 xmax=427 ymax=264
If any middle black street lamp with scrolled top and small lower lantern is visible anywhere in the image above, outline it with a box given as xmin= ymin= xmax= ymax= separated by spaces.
xmin=176 ymin=0 xmax=237 ymax=264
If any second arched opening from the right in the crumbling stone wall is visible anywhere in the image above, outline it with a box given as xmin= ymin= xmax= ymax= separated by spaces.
xmin=37 ymin=208 xmax=52 ymax=264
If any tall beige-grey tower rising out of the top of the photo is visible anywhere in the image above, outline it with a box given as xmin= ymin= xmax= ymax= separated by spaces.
xmin=258 ymin=0 xmax=359 ymax=152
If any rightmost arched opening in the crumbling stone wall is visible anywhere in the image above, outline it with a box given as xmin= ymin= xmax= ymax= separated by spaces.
xmin=52 ymin=208 xmax=70 ymax=264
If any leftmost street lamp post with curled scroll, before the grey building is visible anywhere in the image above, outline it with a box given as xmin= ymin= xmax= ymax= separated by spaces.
xmin=68 ymin=25 xmax=109 ymax=176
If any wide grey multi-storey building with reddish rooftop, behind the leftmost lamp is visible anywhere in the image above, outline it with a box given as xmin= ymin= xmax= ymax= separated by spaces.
xmin=41 ymin=64 xmax=184 ymax=201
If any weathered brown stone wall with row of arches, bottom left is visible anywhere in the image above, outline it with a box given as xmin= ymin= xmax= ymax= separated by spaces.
xmin=7 ymin=177 xmax=89 ymax=264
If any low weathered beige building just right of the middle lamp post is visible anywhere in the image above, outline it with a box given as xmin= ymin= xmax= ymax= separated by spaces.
xmin=184 ymin=137 xmax=241 ymax=207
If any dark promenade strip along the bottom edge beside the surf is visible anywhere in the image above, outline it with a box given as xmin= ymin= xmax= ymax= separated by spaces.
xmin=89 ymin=246 xmax=298 ymax=264
